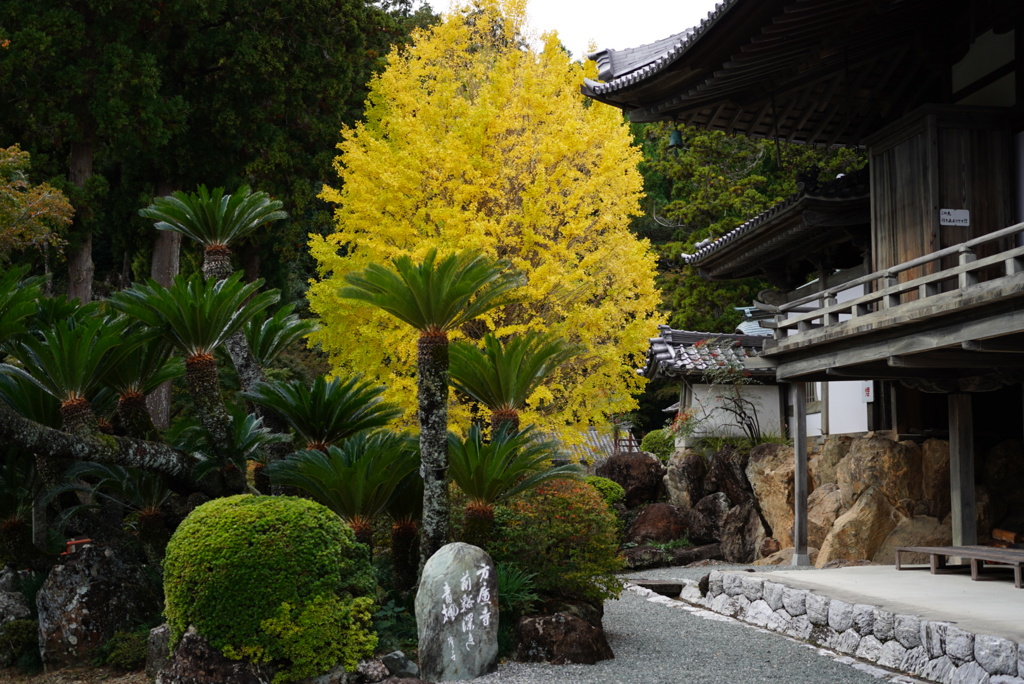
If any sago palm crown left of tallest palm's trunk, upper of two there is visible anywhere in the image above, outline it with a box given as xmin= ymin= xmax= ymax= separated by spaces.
xmin=240 ymin=376 xmax=401 ymax=452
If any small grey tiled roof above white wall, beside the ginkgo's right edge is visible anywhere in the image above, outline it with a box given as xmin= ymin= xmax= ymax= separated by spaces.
xmin=638 ymin=326 xmax=775 ymax=380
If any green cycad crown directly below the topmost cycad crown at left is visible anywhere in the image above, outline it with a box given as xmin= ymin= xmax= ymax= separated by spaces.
xmin=110 ymin=273 xmax=279 ymax=357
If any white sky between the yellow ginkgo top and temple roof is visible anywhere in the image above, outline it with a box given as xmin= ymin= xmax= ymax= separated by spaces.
xmin=429 ymin=0 xmax=716 ymax=58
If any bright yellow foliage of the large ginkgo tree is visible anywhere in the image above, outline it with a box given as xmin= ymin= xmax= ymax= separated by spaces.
xmin=309 ymin=0 xmax=659 ymax=438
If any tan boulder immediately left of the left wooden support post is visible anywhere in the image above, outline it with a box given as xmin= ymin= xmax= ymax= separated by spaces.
xmin=746 ymin=444 xmax=794 ymax=548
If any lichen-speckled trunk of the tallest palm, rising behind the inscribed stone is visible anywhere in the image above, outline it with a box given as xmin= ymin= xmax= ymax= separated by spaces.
xmin=417 ymin=332 xmax=449 ymax=572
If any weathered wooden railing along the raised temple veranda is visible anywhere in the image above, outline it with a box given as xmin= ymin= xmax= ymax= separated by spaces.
xmin=774 ymin=223 xmax=1024 ymax=346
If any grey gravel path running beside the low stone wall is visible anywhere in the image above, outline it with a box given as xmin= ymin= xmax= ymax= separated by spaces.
xmin=475 ymin=566 xmax=920 ymax=684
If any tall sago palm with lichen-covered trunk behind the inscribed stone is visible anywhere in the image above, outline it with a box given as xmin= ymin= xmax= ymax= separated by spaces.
xmin=340 ymin=250 xmax=523 ymax=564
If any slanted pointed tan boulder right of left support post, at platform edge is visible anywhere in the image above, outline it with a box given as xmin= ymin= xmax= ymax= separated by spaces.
xmin=815 ymin=486 xmax=903 ymax=567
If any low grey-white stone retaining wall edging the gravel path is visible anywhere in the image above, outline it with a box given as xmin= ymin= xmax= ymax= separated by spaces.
xmin=682 ymin=570 xmax=1024 ymax=684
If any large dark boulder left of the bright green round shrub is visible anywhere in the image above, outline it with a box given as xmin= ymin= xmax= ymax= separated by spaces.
xmin=36 ymin=544 xmax=163 ymax=669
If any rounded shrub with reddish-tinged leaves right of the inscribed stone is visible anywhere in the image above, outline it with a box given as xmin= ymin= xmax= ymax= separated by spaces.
xmin=487 ymin=480 xmax=623 ymax=602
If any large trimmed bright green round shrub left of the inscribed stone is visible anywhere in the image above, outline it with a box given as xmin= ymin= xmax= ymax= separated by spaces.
xmin=164 ymin=495 xmax=377 ymax=682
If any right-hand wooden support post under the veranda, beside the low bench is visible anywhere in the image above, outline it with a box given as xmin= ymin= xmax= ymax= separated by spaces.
xmin=949 ymin=394 xmax=978 ymax=546
